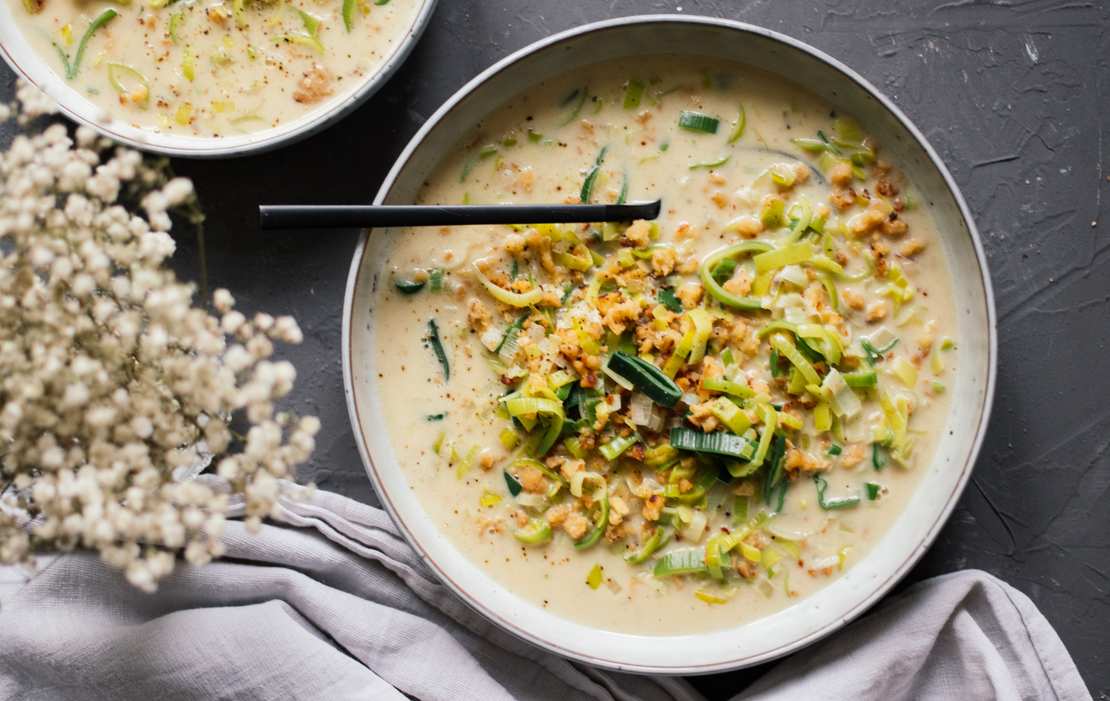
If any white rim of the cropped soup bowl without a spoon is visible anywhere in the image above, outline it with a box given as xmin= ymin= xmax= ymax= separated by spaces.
xmin=0 ymin=0 xmax=438 ymax=160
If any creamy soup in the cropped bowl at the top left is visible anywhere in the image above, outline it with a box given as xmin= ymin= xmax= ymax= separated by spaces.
xmin=8 ymin=0 xmax=420 ymax=136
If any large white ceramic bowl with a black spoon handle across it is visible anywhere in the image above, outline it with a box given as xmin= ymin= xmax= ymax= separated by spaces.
xmin=343 ymin=16 xmax=997 ymax=674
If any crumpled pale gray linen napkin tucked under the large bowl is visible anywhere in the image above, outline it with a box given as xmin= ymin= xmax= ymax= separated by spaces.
xmin=0 ymin=483 xmax=1090 ymax=701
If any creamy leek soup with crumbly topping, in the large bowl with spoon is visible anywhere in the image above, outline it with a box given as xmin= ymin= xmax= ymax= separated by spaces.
xmin=367 ymin=57 xmax=957 ymax=634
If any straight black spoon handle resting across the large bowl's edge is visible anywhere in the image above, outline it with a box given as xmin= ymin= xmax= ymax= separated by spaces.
xmin=259 ymin=200 xmax=663 ymax=228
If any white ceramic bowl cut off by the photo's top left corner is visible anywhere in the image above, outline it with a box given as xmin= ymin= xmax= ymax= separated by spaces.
xmin=0 ymin=0 xmax=436 ymax=159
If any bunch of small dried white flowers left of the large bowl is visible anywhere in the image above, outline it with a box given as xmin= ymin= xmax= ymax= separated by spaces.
xmin=0 ymin=85 xmax=320 ymax=590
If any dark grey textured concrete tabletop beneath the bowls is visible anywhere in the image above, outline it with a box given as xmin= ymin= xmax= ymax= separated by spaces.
xmin=0 ymin=0 xmax=1110 ymax=699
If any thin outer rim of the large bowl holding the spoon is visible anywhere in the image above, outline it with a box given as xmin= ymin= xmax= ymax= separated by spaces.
xmin=341 ymin=13 xmax=998 ymax=675
